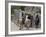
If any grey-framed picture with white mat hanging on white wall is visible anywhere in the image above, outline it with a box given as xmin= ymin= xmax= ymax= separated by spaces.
xmin=5 ymin=1 xmax=45 ymax=35
